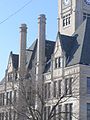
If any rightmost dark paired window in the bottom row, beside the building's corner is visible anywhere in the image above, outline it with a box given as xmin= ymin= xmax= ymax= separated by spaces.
xmin=65 ymin=103 xmax=72 ymax=120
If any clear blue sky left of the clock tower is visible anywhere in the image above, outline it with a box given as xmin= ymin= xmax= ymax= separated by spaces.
xmin=0 ymin=0 xmax=58 ymax=80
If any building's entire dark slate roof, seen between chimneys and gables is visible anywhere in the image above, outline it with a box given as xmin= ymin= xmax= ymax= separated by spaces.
xmin=6 ymin=18 xmax=90 ymax=72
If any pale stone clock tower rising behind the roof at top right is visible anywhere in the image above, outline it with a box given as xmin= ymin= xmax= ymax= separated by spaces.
xmin=58 ymin=0 xmax=90 ymax=36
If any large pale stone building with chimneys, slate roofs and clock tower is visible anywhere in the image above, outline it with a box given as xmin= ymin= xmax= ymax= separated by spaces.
xmin=0 ymin=0 xmax=90 ymax=120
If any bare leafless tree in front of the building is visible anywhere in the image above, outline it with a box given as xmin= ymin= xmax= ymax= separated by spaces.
xmin=10 ymin=70 xmax=79 ymax=120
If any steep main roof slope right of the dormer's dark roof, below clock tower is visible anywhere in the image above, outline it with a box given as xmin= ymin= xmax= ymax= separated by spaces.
xmin=67 ymin=19 xmax=90 ymax=66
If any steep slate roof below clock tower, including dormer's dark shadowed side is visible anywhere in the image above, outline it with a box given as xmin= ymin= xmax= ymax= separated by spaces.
xmin=58 ymin=18 xmax=90 ymax=66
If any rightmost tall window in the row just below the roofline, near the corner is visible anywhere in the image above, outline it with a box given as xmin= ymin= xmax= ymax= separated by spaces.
xmin=65 ymin=78 xmax=72 ymax=95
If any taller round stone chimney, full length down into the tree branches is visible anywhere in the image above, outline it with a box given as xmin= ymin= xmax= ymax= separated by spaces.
xmin=35 ymin=14 xmax=46 ymax=108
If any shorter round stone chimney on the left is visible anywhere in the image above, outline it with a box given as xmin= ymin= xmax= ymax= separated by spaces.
xmin=19 ymin=24 xmax=27 ymax=77
